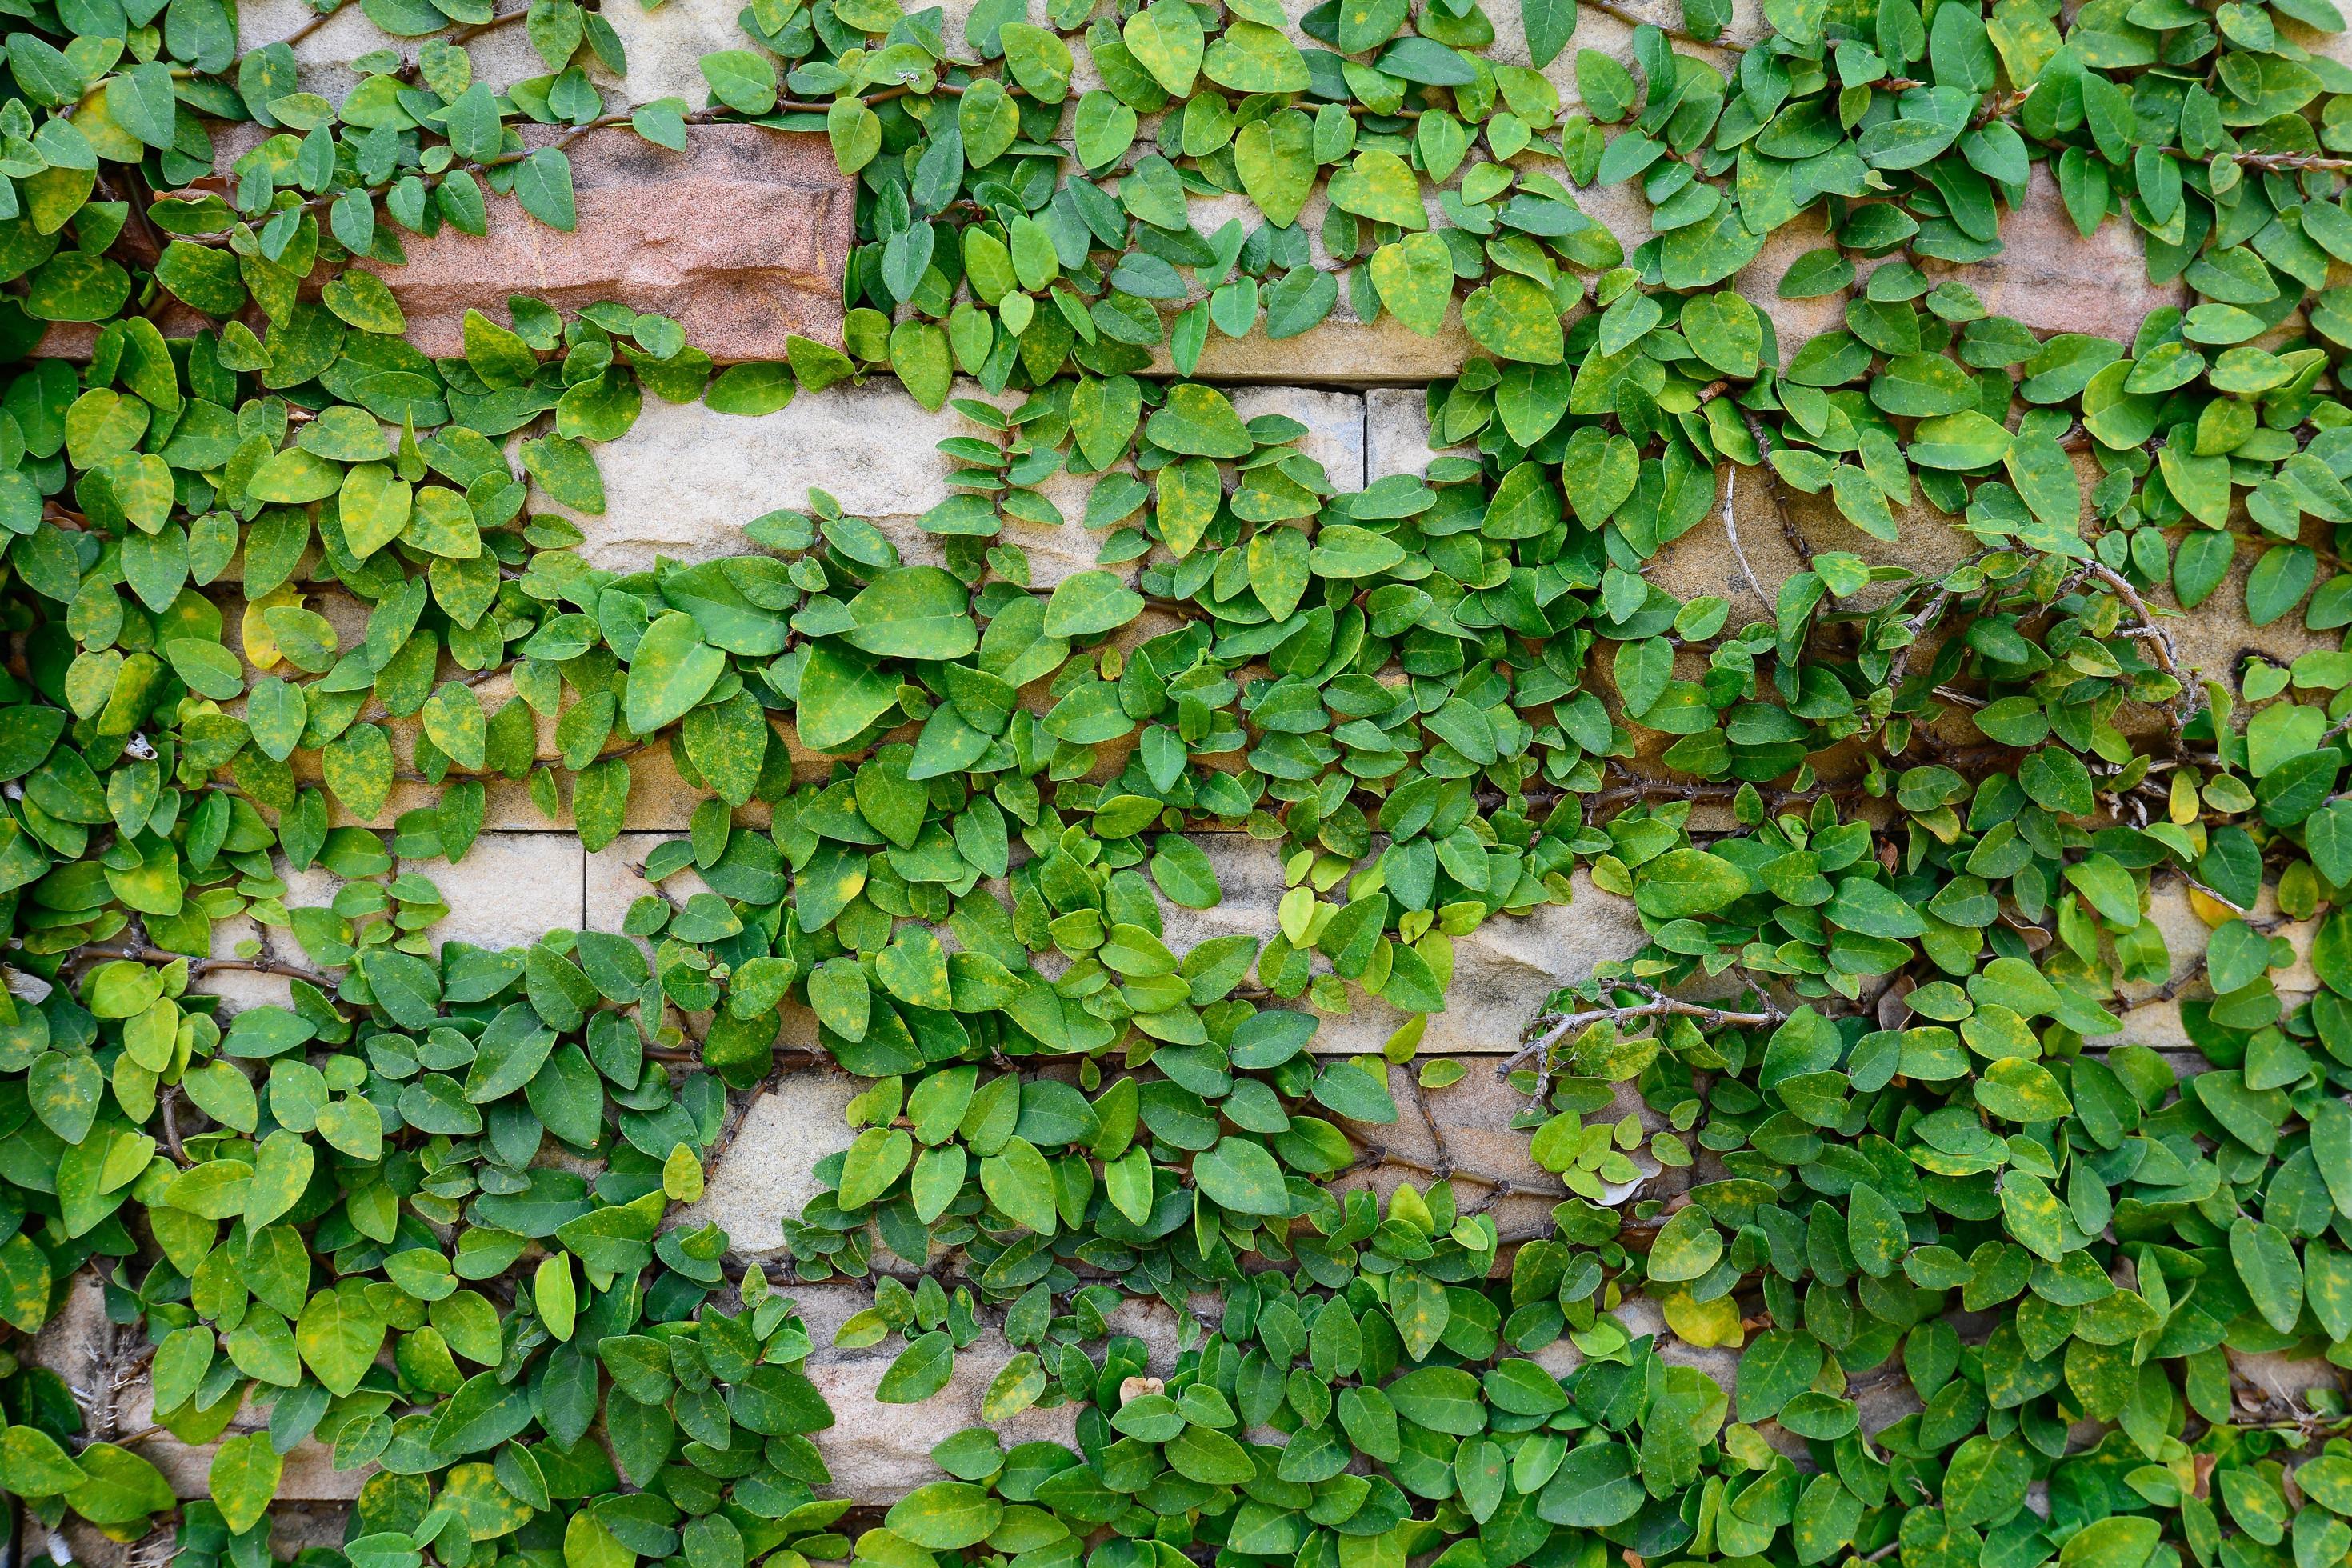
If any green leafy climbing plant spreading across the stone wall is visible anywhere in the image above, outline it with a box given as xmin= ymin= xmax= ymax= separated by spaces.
xmin=0 ymin=0 xmax=2352 ymax=1568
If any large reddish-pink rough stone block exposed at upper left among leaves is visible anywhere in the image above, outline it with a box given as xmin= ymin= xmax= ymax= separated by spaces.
xmin=372 ymin=125 xmax=856 ymax=360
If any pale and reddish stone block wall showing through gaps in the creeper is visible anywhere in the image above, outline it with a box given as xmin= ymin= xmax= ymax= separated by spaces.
xmin=35 ymin=0 xmax=2333 ymax=1561
